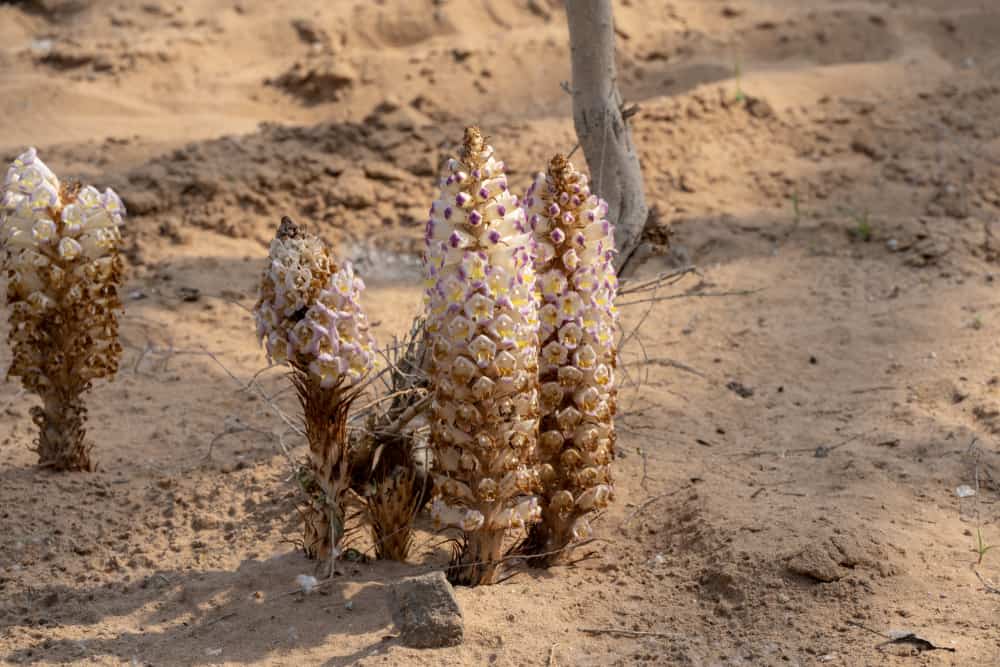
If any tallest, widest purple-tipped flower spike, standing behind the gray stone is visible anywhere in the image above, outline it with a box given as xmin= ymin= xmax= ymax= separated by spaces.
xmin=425 ymin=127 xmax=538 ymax=585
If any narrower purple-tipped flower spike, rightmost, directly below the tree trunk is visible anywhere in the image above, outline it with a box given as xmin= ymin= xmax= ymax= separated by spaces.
xmin=523 ymin=155 xmax=618 ymax=548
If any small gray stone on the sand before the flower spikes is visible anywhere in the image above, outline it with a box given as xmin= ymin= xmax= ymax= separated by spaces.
xmin=389 ymin=571 xmax=465 ymax=648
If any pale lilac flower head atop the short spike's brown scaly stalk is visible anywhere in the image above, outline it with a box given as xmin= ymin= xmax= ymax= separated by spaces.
xmin=254 ymin=218 xmax=376 ymax=388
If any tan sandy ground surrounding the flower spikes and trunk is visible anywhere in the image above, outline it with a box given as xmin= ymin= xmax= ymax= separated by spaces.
xmin=0 ymin=0 xmax=1000 ymax=666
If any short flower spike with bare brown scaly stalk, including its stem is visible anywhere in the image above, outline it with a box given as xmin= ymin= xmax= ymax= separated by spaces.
xmin=254 ymin=217 xmax=375 ymax=559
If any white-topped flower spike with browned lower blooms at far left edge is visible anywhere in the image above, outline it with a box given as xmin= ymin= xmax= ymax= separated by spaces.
xmin=0 ymin=148 xmax=125 ymax=470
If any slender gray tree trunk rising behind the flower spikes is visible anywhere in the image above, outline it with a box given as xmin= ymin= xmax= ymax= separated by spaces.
xmin=566 ymin=0 xmax=649 ymax=270
